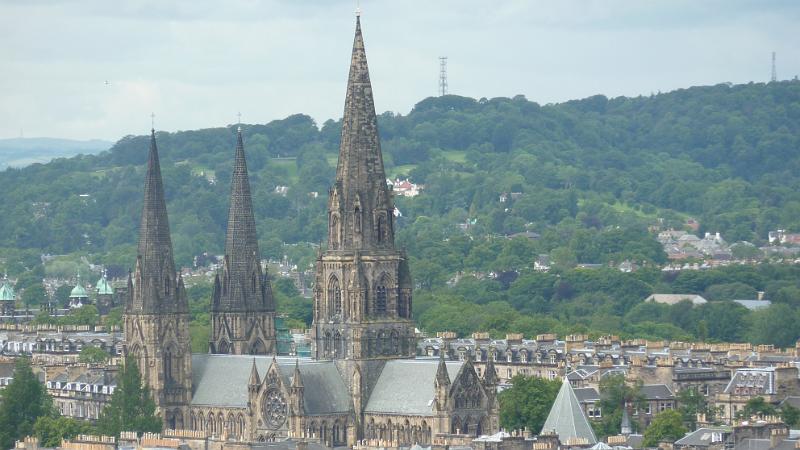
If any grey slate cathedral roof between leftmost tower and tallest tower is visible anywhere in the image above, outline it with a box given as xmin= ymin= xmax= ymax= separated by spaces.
xmin=192 ymin=354 xmax=351 ymax=415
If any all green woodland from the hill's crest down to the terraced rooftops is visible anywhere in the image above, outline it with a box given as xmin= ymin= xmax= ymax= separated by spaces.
xmin=0 ymin=81 xmax=800 ymax=351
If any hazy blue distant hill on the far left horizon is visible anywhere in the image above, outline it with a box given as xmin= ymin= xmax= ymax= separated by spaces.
xmin=0 ymin=138 xmax=114 ymax=170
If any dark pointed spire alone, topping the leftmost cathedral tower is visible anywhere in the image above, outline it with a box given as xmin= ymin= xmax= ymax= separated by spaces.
xmin=127 ymin=130 xmax=188 ymax=314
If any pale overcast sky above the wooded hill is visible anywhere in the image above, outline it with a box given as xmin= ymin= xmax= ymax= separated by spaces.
xmin=0 ymin=0 xmax=800 ymax=140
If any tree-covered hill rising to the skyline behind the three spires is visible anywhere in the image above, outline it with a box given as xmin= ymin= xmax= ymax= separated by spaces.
xmin=0 ymin=81 xmax=800 ymax=346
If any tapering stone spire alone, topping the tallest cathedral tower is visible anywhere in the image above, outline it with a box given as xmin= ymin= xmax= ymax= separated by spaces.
xmin=328 ymin=17 xmax=394 ymax=250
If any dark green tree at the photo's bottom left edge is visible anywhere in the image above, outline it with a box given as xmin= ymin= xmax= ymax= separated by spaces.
xmin=0 ymin=358 xmax=55 ymax=448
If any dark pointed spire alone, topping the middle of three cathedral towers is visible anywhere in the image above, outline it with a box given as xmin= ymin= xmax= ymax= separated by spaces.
xmin=212 ymin=127 xmax=275 ymax=312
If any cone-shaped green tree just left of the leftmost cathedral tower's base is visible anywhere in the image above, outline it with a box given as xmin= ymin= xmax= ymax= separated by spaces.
xmin=97 ymin=357 xmax=162 ymax=436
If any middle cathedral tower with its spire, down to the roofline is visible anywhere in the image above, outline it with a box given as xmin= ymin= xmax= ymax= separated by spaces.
xmin=210 ymin=127 xmax=276 ymax=355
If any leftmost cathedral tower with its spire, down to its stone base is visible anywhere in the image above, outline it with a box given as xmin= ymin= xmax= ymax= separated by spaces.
xmin=123 ymin=130 xmax=192 ymax=428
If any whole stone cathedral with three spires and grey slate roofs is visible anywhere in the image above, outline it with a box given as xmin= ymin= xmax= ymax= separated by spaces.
xmin=124 ymin=13 xmax=499 ymax=447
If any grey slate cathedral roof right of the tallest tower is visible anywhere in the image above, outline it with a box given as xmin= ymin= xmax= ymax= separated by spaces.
xmin=364 ymin=359 xmax=463 ymax=415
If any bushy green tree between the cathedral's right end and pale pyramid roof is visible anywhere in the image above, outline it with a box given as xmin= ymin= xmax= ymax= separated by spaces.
xmin=499 ymin=375 xmax=561 ymax=433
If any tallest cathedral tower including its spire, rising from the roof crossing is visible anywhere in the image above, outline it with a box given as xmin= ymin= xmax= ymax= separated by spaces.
xmin=313 ymin=12 xmax=416 ymax=400
